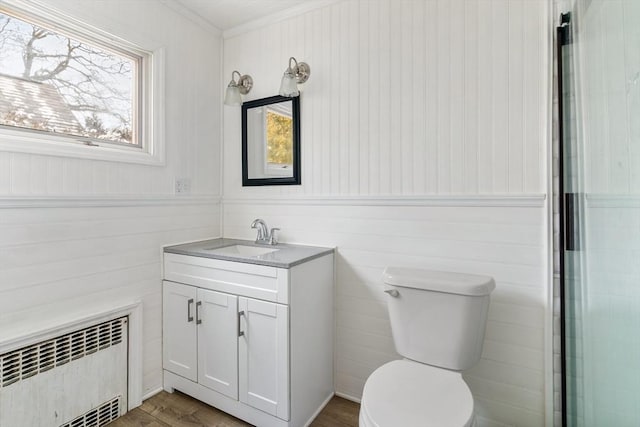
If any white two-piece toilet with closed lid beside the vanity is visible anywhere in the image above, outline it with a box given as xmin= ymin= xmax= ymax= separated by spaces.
xmin=360 ymin=267 xmax=495 ymax=427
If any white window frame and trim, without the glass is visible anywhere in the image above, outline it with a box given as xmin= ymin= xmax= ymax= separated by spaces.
xmin=0 ymin=0 xmax=165 ymax=166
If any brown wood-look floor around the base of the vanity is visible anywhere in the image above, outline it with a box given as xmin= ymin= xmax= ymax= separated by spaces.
xmin=109 ymin=391 xmax=360 ymax=427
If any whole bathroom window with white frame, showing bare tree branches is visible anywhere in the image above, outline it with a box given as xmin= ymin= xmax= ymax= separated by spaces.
xmin=0 ymin=1 xmax=166 ymax=163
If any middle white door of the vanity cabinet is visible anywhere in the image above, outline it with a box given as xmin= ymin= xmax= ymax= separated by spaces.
xmin=197 ymin=289 xmax=239 ymax=400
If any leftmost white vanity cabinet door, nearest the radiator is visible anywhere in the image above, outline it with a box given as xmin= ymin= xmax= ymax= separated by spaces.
xmin=162 ymin=281 xmax=198 ymax=381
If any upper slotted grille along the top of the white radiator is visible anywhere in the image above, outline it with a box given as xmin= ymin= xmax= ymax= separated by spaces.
xmin=0 ymin=317 xmax=127 ymax=390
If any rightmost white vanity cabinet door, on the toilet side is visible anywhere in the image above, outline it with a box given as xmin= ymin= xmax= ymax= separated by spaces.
xmin=238 ymin=297 xmax=289 ymax=420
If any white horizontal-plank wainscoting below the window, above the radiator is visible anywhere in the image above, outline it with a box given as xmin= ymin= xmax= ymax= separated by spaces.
xmin=0 ymin=198 xmax=220 ymax=394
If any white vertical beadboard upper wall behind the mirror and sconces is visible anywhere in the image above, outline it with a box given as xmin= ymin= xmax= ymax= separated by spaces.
xmin=223 ymin=0 xmax=549 ymax=195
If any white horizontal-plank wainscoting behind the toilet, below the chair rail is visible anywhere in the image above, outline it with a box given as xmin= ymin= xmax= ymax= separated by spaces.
xmin=223 ymin=197 xmax=550 ymax=426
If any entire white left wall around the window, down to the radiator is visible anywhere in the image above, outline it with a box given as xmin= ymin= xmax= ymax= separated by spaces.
xmin=0 ymin=0 xmax=222 ymax=400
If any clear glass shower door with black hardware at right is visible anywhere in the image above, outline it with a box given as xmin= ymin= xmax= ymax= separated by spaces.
xmin=558 ymin=0 xmax=640 ymax=427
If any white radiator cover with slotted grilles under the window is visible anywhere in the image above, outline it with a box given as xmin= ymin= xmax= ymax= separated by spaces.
xmin=0 ymin=317 xmax=128 ymax=427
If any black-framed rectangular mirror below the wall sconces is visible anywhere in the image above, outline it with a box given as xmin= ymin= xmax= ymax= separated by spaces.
xmin=242 ymin=96 xmax=300 ymax=187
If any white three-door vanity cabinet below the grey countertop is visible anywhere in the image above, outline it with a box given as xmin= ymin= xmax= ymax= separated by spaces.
xmin=163 ymin=249 xmax=333 ymax=427
